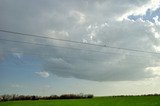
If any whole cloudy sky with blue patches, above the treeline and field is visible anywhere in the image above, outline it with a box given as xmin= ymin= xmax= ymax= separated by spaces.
xmin=0 ymin=0 xmax=160 ymax=96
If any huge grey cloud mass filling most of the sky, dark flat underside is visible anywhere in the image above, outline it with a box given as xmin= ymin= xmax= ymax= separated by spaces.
xmin=0 ymin=0 xmax=160 ymax=81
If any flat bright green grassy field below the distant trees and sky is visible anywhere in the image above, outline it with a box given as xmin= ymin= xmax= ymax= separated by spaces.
xmin=0 ymin=96 xmax=160 ymax=106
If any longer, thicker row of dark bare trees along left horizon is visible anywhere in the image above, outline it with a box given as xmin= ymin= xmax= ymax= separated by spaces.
xmin=0 ymin=94 xmax=93 ymax=101
